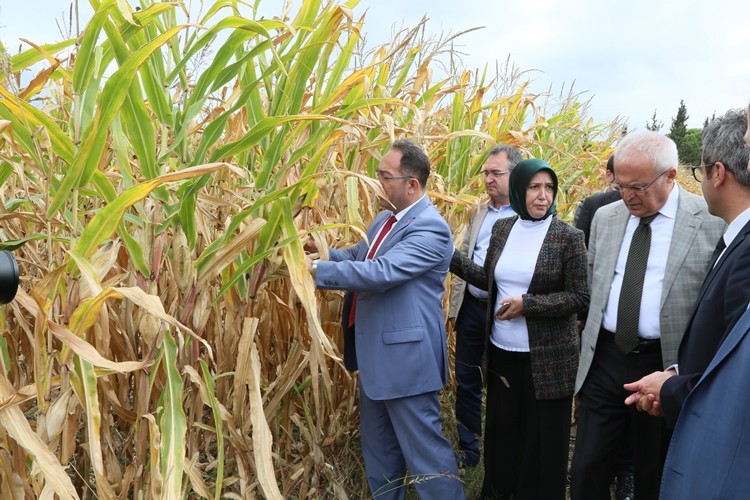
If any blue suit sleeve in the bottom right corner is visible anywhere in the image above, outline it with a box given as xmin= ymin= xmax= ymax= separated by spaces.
xmin=660 ymin=304 xmax=750 ymax=500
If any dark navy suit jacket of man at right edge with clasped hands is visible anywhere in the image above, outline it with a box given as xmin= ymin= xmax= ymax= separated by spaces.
xmin=660 ymin=219 xmax=750 ymax=427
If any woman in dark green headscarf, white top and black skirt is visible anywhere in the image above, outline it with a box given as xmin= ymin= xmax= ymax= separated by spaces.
xmin=451 ymin=159 xmax=589 ymax=500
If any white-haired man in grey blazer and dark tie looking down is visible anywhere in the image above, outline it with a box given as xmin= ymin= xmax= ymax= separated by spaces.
xmin=571 ymin=132 xmax=724 ymax=500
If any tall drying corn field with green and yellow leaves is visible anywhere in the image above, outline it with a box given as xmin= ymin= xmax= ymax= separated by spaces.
xmin=0 ymin=0 xmax=622 ymax=499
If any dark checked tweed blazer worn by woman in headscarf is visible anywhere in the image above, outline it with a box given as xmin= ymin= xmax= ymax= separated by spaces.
xmin=451 ymin=216 xmax=589 ymax=399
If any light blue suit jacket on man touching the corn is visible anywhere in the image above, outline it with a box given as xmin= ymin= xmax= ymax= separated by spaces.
xmin=315 ymin=196 xmax=453 ymax=400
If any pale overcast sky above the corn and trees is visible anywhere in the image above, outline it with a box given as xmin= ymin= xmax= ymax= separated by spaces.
xmin=0 ymin=0 xmax=750 ymax=131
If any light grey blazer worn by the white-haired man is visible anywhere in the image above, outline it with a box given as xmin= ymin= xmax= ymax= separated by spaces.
xmin=576 ymin=186 xmax=726 ymax=393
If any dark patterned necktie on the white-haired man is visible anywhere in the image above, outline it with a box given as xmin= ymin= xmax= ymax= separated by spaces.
xmin=615 ymin=212 xmax=658 ymax=354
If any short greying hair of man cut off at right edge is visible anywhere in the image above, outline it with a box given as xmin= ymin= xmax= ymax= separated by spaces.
xmin=701 ymin=109 xmax=750 ymax=187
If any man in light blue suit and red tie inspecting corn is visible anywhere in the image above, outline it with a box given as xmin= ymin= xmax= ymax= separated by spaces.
xmin=308 ymin=141 xmax=464 ymax=499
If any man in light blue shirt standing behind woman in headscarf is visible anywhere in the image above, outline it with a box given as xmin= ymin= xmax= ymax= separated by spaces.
xmin=448 ymin=144 xmax=521 ymax=467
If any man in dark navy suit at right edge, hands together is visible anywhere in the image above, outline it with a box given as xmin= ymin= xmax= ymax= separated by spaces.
xmin=625 ymin=110 xmax=750 ymax=427
